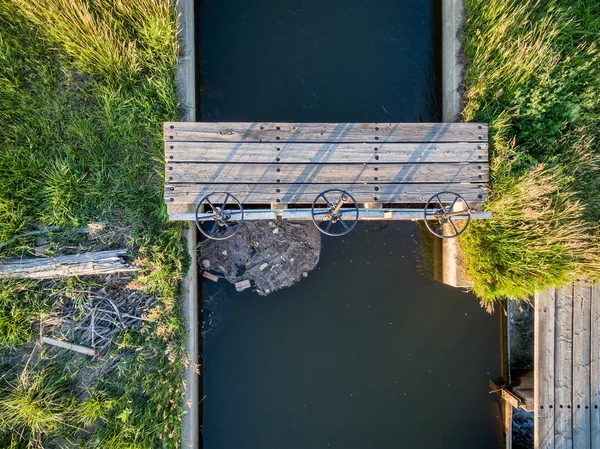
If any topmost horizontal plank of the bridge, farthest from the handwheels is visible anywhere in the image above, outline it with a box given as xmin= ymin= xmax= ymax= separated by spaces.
xmin=164 ymin=122 xmax=488 ymax=143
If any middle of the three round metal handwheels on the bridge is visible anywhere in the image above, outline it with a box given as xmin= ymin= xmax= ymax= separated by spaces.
xmin=311 ymin=189 xmax=358 ymax=237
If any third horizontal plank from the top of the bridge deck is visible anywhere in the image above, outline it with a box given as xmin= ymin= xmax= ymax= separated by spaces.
xmin=166 ymin=162 xmax=488 ymax=184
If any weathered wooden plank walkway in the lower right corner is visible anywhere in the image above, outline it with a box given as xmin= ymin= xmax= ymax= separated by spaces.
xmin=534 ymin=281 xmax=600 ymax=449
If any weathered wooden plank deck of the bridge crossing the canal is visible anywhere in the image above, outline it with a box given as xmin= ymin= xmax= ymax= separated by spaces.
xmin=164 ymin=122 xmax=489 ymax=220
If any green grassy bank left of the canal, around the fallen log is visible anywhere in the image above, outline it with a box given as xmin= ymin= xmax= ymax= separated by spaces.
xmin=0 ymin=0 xmax=184 ymax=448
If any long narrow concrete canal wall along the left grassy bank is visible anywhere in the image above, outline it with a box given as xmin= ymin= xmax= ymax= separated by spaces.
xmin=176 ymin=0 xmax=201 ymax=449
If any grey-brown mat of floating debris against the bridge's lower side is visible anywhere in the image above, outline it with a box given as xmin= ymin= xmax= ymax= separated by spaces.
xmin=200 ymin=221 xmax=321 ymax=295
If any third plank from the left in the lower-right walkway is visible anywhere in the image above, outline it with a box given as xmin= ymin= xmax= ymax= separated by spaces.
xmin=572 ymin=281 xmax=592 ymax=449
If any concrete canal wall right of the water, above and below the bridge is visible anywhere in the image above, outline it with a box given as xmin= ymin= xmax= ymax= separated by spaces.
xmin=434 ymin=0 xmax=473 ymax=288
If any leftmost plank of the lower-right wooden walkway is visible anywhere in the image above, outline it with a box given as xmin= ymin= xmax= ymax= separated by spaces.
xmin=534 ymin=288 xmax=555 ymax=449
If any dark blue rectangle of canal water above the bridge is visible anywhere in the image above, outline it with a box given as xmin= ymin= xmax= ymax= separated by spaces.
xmin=199 ymin=0 xmax=439 ymax=123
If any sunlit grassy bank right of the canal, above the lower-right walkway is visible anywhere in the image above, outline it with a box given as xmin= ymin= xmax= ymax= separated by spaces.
xmin=461 ymin=0 xmax=600 ymax=302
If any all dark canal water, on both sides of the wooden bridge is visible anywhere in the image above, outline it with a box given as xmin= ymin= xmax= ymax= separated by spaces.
xmin=199 ymin=0 xmax=501 ymax=449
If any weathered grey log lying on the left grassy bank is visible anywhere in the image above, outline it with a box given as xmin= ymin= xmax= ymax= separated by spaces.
xmin=0 ymin=249 xmax=140 ymax=279
